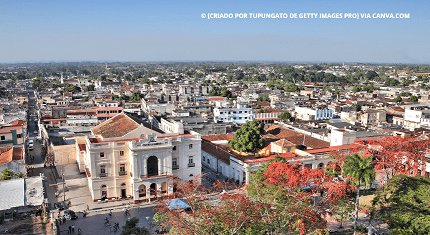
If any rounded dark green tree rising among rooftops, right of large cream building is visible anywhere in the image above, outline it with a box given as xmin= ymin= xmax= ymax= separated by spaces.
xmin=228 ymin=120 xmax=264 ymax=152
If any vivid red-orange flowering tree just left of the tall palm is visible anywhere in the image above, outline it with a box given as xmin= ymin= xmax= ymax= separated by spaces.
xmin=248 ymin=161 xmax=355 ymax=234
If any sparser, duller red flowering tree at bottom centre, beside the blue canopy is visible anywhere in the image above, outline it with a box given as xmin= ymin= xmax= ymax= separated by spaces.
xmin=154 ymin=179 xmax=271 ymax=235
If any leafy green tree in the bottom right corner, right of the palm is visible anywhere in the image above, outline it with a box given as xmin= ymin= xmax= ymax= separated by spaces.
xmin=372 ymin=175 xmax=430 ymax=235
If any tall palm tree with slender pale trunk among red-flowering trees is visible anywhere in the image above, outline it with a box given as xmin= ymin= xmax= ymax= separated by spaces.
xmin=343 ymin=153 xmax=376 ymax=235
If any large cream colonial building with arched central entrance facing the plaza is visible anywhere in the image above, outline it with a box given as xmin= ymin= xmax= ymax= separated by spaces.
xmin=77 ymin=113 xmax=201 ymax=203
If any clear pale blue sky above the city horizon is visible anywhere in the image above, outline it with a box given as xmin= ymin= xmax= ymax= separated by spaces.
xmin=0 ymin=0 xmax=430 ymax=63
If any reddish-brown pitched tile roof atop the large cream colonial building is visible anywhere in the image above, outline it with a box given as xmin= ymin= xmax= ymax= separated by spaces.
xmin=92 ymin=113 xmax=140 ymax=138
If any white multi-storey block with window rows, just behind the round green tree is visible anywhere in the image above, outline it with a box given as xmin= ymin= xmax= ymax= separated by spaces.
xmin=214 ymin=103 xmax=255 ymax=124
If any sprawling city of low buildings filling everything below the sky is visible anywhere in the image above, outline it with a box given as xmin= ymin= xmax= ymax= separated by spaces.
xmin=0 ymin=62 xmax=430 ymax=234
